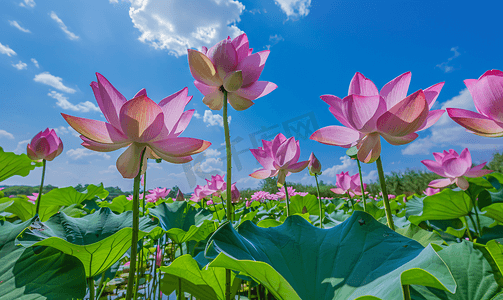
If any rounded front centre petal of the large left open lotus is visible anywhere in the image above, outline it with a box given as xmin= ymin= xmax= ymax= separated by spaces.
xmin=119 ymin=96 xmax=164 ymax=143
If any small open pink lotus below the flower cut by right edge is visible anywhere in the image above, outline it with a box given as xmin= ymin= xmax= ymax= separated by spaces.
xmin=421 ymin=148 xmax=493 ymax=190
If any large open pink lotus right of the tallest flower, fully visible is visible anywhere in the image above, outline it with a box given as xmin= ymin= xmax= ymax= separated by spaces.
xmin=310 ymin=72 xmax=444 ymax=163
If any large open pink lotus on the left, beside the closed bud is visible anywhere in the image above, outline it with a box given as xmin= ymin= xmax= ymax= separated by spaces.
xmin=61 ymin=73 xmax=211 ymax=178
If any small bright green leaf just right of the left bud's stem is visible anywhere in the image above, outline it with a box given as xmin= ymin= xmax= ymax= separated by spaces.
xmin=40 ymin=183 xmax=108 ymax=206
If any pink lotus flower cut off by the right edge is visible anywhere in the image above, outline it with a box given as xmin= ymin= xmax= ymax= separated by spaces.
xmin=447 ymin=70 xmax=503 ymax=137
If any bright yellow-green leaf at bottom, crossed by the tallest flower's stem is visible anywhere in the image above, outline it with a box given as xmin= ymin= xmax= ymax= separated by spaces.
xmin=160 ymin=254 xmax=241 ymax=300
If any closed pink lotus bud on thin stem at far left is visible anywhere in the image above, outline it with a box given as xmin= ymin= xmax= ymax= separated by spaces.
xmin=26 ymin=128 xmax=63 ymax=161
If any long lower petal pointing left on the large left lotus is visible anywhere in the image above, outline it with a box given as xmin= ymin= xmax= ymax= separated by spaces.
xmin=61 ymin=113 xmax=128 ymax=144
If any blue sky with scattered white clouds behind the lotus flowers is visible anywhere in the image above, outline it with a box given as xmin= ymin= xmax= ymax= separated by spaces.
xmin=0 ymin=0 xmax=503 ymax=192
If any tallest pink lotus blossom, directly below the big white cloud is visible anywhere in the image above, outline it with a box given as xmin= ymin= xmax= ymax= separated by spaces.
xmin=188 ymin=33 xmax=277 ymax=110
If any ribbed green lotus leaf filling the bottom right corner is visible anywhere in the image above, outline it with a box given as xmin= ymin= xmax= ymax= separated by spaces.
xmin=410 ymin=242 xmax=502 ymax=300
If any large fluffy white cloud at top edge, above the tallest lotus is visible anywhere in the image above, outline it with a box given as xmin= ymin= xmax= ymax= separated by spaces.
xmin=129 ymin=0 xmax=245 ymax=56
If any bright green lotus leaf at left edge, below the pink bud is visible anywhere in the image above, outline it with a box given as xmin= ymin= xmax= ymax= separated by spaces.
xmin=0 ymin=147 xmax=42 ymax=182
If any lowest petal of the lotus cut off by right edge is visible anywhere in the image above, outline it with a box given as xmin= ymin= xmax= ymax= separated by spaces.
xmin=447 ymin=108 xmax=503 ymax=137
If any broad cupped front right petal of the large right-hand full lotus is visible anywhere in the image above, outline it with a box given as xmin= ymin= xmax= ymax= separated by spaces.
xmin=377 ymin=90 xmax=428 ymax=136
